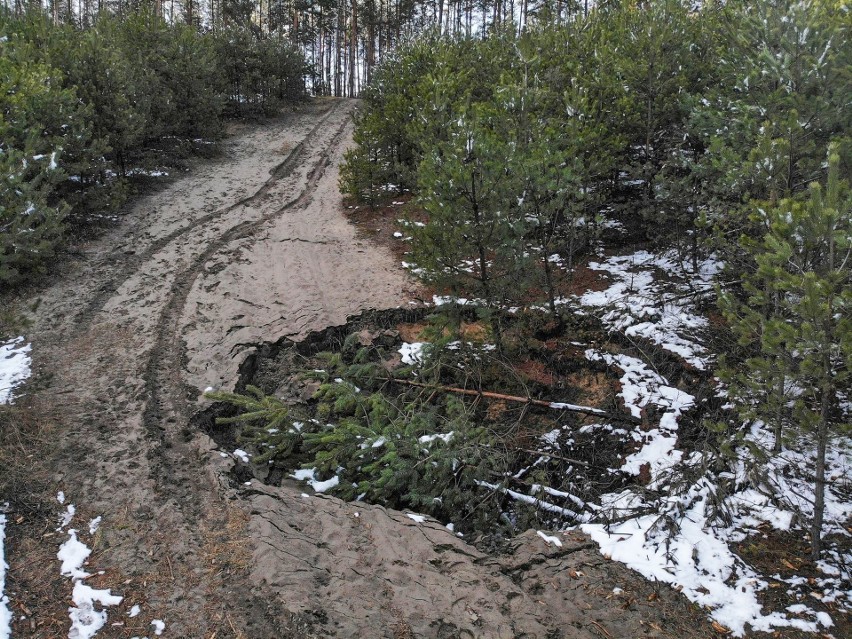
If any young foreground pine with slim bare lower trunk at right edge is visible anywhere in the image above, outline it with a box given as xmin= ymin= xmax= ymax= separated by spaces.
xmin=721 ymin=146 xmax=852 ymax=560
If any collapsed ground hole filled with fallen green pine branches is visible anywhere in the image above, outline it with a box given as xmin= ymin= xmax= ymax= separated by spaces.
xmin=194 ymin=307 xmax=703 ymax=549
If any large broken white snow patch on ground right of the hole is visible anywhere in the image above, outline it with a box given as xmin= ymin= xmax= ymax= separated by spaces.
xmin=572 ymin=251 xmax=852 ymax=637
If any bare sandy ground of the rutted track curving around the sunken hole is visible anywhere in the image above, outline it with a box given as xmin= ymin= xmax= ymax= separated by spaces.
xmin=1 ymin=101 xmax=714 ymax=639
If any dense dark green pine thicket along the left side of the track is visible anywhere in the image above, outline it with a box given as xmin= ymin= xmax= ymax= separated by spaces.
xmin=0 ymin=11 xmax=305 ymax=285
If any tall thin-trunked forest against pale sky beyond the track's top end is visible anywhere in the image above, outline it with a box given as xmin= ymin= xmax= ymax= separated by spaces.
xmin=2 ymin=0 xmax=652 ymax=97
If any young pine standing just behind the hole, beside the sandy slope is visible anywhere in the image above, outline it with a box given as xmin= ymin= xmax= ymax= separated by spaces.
xmin=411 ymin=104 xmax=528 ymax=348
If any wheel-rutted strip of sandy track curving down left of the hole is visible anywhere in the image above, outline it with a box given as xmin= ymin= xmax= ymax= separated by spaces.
xmin=15 ymin=100 xmax=354 ymax=639
